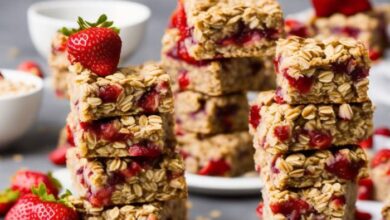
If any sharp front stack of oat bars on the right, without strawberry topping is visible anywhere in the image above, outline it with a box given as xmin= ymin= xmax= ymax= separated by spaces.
xmin=249 ymin=37 xmax=373 ymax=220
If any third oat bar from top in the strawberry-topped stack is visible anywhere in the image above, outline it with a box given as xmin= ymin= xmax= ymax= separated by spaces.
xmin=67 ymin=149 xmax=187 ymax=207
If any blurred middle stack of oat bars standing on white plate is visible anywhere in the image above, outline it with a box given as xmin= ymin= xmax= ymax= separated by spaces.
xmin=162 ymin=0 xmax=283 ymax=176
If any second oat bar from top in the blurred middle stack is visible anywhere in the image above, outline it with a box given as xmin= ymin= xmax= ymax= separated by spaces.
xmin=162 ymin=29 xmax=274 ymax=96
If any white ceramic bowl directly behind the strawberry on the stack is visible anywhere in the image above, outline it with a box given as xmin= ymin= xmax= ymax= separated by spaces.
xmin=28 ymin=0 xmax=150 ymax=58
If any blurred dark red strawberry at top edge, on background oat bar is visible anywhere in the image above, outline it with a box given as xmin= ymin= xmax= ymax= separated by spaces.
xmin=312 ymin=0 xmax=372 ymax=17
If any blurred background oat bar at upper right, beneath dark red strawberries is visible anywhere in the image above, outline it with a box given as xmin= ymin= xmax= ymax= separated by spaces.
xmin=311 ymin=11 xmax=387 ymax=60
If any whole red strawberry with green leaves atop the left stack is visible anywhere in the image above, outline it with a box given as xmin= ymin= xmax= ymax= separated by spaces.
xmin=61 ymin=15 xmax=122 ymax=76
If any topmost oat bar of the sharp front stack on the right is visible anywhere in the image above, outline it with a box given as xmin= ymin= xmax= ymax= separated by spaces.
xmin=275 ymin=37 xmax=370 ymax=104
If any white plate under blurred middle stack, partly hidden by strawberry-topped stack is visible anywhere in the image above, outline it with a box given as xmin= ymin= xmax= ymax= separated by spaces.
xmin=53 ymin=169 xmax=263 ymax=196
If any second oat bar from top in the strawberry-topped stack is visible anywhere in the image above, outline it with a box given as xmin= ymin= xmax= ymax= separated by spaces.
xmin=67 ymin=113 xmax=176 ymax=158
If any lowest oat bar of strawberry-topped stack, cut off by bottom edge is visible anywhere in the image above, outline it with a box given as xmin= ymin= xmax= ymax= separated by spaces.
xmin=70 ymin=198 xmax=187 ymax=220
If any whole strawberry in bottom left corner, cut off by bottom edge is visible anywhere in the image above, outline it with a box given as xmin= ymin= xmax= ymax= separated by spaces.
xmin=5 ymin=184 xmax=79 ymax=220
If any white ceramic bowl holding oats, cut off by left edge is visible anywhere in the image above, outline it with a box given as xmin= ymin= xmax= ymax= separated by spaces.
xmin=0 ymin=69 xmax=43 ymax=149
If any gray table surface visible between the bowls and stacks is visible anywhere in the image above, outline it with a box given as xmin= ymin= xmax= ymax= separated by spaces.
xmin=0 ymin=0 xmax=389 ymax=220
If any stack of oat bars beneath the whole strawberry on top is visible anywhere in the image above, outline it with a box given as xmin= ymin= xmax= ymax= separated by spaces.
xmin=67 ymin=63 xmax=187 ymax=220
